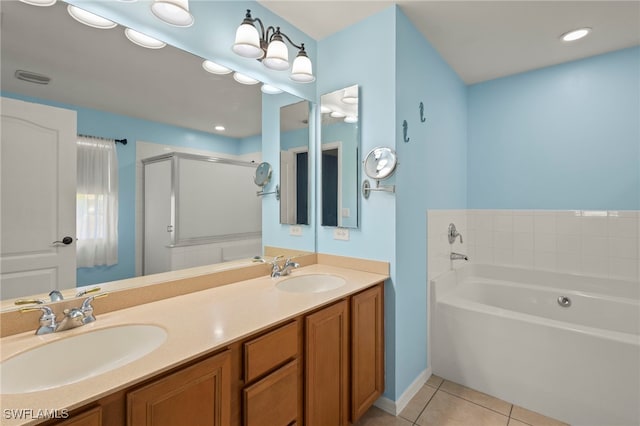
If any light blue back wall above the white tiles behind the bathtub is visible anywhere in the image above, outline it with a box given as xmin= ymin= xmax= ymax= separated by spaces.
xmin=468 ymin=47 xmax=640 ymax=210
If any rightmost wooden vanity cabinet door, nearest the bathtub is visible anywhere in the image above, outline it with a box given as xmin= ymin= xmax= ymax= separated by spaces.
xmin=351 ymin=283 xmax=384 ymax=423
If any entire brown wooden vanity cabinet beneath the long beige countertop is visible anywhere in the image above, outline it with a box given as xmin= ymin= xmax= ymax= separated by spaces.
xmin=45 ymin=282 xmax=384 ymax=426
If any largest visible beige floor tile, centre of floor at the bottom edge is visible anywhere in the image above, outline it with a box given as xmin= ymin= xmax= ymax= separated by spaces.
xmin=416 ymin=390 xmax=509 ymax=426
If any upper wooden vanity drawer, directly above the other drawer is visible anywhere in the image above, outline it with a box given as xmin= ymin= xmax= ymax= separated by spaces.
xmin=244 ymin=322 xmax=298 ymax=383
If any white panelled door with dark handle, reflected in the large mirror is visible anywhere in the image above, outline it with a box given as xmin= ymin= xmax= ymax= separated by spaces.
xmin=0 ymin=97 xmax=76 ymax=299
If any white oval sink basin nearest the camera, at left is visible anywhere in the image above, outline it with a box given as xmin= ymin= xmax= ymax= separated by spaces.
xmin=0 ymin=324 xmax=167 ymax=394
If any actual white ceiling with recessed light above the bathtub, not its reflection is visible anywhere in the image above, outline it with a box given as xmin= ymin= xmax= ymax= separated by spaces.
xmin=260 ymin=0 xmax=640 ymax=84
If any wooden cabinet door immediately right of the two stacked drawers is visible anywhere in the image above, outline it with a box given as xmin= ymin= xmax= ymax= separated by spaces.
xmin=305 ymin=300 xmax=349 ymax=426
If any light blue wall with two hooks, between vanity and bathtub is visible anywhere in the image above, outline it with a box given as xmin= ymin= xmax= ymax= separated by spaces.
xmin=396 ymin=10 xmax=467 ymax=398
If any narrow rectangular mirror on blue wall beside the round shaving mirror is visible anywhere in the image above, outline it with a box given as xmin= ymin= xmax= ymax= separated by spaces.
xmin=320 ymin=85 xmax=360 ymax=228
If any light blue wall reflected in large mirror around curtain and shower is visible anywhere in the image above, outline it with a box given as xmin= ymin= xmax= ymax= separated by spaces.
xmin=2 ymin=92 xmax=252 ymax=286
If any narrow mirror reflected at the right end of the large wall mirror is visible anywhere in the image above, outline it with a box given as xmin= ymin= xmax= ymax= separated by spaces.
xmin=280 ymin=101 xmax=309 ymax=225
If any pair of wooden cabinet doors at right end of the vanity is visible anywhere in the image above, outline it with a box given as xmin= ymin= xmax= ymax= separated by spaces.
xmin=305 ymin=283 xmax=384 ymax=426
